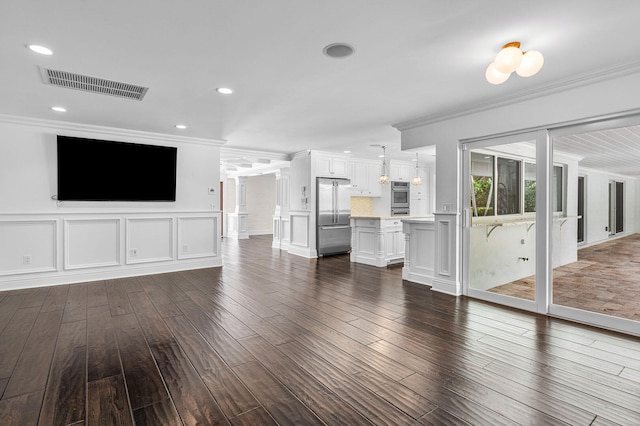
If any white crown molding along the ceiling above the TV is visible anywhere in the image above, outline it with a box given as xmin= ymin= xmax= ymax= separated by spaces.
xmin=0 ymin=114 xmax=227 ymax=146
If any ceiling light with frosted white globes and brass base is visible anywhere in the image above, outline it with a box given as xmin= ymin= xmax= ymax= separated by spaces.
xmin=485 ymin=41 xmax=544 ymax=84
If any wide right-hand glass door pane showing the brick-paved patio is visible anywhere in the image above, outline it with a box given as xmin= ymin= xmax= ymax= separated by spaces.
xmin=550 ymin=128 xmax=640 ymax=326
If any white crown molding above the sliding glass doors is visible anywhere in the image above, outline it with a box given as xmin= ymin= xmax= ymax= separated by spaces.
xmin=392 ymin=61 xmax=640 ymax=131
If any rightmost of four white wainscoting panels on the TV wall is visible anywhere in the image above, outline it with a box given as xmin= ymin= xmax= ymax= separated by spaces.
xmin=178 ymin=216 xmax=220 ymax=259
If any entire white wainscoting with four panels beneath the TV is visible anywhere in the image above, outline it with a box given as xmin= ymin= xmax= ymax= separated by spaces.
xmin=0 ymin=212 xmax=222 ymax=291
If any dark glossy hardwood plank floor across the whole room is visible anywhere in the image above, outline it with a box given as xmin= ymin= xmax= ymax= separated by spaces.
xmin=0 ymin=237 xmax=640 ymax=425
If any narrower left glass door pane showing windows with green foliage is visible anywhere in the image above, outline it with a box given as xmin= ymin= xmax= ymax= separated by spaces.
xmin=465 ymin=141 xmax=537 ymax=304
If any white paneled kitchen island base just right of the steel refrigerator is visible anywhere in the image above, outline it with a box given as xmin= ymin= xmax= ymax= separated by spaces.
xmin=351 ymin=216 xmax=405 ymax=267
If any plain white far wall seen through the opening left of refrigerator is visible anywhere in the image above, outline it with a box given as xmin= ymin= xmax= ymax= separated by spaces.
xmin=247 ymin=174 xmax=276 ymax=235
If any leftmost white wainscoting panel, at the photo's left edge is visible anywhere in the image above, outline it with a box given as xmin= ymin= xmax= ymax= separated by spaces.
xmin=0 ymin=219 xmax=58 ymax=275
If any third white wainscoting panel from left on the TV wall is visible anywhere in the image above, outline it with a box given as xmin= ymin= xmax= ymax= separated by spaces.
xmin=126 ymin=217 xmax=175 ymax=264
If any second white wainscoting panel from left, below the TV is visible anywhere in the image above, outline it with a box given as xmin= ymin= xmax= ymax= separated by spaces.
xmin=64 ymin=218 xmax=121 ymax=269
